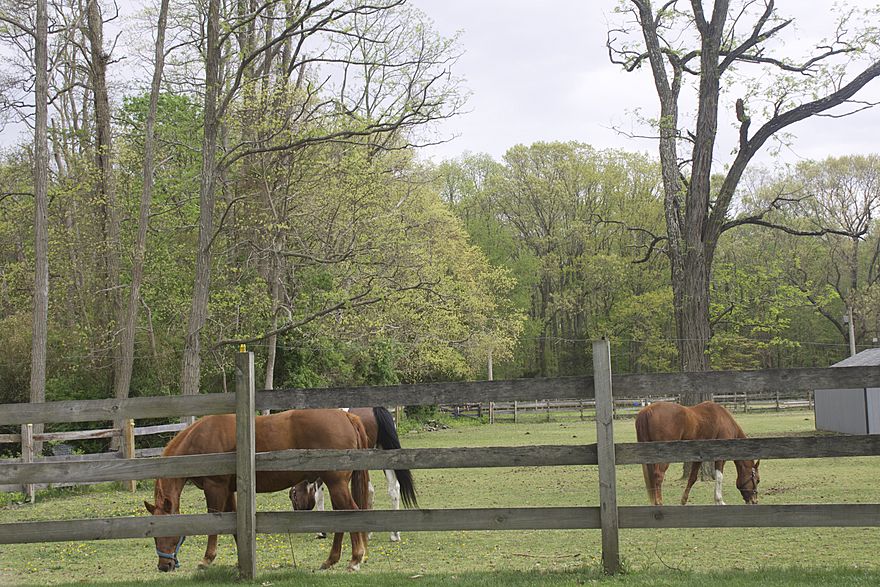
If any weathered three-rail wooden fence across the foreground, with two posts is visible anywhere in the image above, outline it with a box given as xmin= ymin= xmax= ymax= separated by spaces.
xmin=0 ymin=341 xmax=880 ymax=578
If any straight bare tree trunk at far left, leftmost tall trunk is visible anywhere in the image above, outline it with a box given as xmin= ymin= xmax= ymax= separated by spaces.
xmin=30 ymin=0 xmax=49 ymax=454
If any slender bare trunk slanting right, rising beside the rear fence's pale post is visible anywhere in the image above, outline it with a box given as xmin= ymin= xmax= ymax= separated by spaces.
xmin=113 ymin=0 xmax=168 ymax=428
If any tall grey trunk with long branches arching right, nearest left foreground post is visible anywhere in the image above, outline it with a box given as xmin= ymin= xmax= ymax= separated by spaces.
xmin=181 ymin=0 xmax=220 ymax=402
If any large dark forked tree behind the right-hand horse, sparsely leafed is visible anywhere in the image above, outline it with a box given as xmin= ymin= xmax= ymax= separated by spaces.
xmin=607 ymin=0 xmax=880 ymax=396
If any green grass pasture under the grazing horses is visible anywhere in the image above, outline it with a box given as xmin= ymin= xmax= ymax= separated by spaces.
xmin=0 ymin=411 xmax=880 ymax=585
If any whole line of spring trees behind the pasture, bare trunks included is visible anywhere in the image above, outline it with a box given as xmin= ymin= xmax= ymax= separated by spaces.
xmin=0 ymin=0 xmax=880 ymax=420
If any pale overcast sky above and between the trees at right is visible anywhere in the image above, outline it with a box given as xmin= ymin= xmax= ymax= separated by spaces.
xmin=410 ymin=0 xmax=880 ymax=168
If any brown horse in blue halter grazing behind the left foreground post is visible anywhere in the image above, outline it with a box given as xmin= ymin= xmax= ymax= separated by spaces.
xmin=144 ymin=410 xmax=369 ymax=571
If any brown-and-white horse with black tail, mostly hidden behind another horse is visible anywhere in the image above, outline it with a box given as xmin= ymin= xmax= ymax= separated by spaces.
xmin=290 ymin=406 xmax=418 ymax=542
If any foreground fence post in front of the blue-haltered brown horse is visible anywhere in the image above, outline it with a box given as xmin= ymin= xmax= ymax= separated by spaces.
xmin=235 ymin=345 xmax=257 ymax=580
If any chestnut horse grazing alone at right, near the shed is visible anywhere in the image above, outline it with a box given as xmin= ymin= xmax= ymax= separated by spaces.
xmin=636 ymin=402 xmax=760 ymax=505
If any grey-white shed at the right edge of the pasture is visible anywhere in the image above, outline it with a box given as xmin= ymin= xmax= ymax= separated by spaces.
xmin=815 ymin=348 xmax=880 ymax=434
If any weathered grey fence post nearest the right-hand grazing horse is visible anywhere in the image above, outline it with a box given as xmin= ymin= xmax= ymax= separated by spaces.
xmin=593 ymin=339 xmax=620 ymax=575
